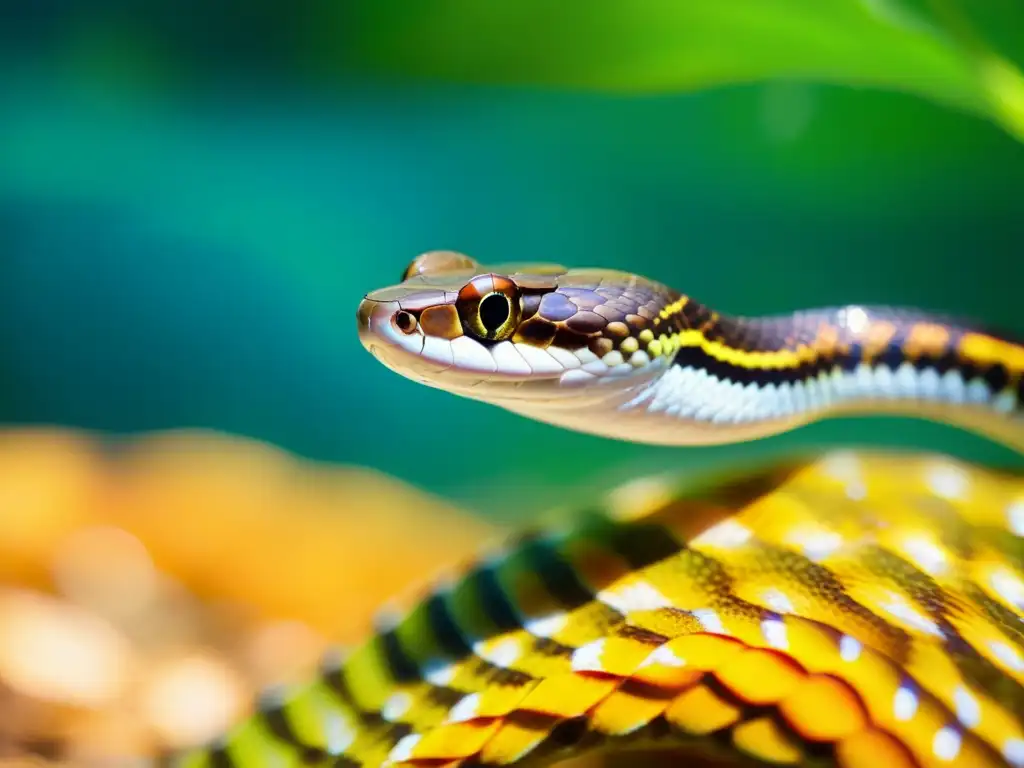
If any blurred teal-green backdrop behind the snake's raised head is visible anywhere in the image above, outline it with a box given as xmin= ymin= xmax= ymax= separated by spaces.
xmin=0 ymin=0 xmax=1024 ymax=515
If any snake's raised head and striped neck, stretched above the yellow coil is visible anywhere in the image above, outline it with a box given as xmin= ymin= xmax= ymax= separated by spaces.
xmin=358 ymin=252 xmax=1024 ymax=447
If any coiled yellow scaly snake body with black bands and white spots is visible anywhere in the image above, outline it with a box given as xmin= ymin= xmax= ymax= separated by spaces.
xmin=169 ymin=454 xmax=1024 ymax=768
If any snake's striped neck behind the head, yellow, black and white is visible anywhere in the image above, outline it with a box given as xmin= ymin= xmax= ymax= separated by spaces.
xmin=512 ymin=301 xmax=1024 ymax=451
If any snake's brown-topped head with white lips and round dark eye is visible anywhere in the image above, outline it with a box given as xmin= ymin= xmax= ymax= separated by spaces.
xmin=357 ymin=251 xmax=678 ymax=407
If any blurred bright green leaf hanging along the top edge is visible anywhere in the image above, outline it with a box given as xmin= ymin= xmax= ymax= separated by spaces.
xmin=316 ymin=0 xmax=1024 ymax=138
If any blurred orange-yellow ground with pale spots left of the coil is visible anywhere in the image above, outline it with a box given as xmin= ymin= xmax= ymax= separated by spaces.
xmin=0 ymin=430 xmax=496 ymax=768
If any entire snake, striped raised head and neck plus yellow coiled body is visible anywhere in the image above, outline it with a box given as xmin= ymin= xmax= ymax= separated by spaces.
xmin=168 ymin=251 xmax=1024 ymax=768
